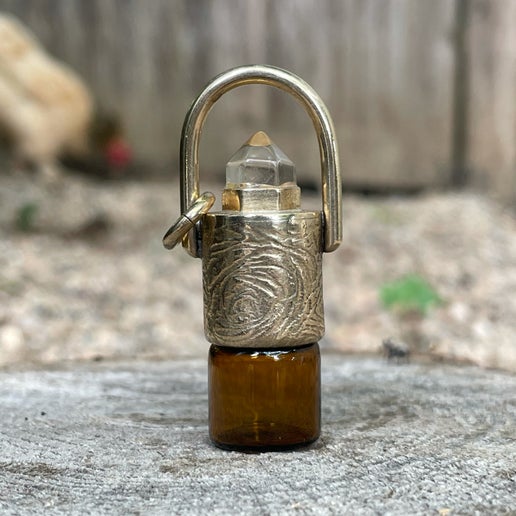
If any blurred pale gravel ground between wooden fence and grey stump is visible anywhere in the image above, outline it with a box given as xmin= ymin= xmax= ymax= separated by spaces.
xmin=0 ymin=175 xmax=516 ymax=371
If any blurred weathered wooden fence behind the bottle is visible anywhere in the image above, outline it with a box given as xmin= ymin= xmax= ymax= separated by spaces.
xmin=0 ymin=0 xmax=516 ymax=198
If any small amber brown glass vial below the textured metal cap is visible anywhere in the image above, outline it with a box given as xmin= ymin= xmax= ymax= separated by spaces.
xmin=208 ymin=344 xmax=321 ymax=451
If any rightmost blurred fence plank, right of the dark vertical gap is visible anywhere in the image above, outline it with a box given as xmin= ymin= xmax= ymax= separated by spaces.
xmin=468 ymin=0 xmax=516 ymax=199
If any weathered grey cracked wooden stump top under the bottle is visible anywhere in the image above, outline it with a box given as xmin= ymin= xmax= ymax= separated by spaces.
xmin=0 ymin=355 xmax=516 ymax=515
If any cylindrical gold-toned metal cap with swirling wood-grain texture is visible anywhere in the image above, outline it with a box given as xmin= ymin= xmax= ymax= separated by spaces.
xmin=203 ymin=216 xmax=324 ymax=347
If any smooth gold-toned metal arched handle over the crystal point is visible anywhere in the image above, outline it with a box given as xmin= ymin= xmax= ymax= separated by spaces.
xmin=180 ymin=65 xmax=342 ymax=256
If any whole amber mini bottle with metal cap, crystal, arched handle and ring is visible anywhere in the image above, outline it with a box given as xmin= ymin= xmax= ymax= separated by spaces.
xmin=163 ymin=65 xmax=342 ymax=451
